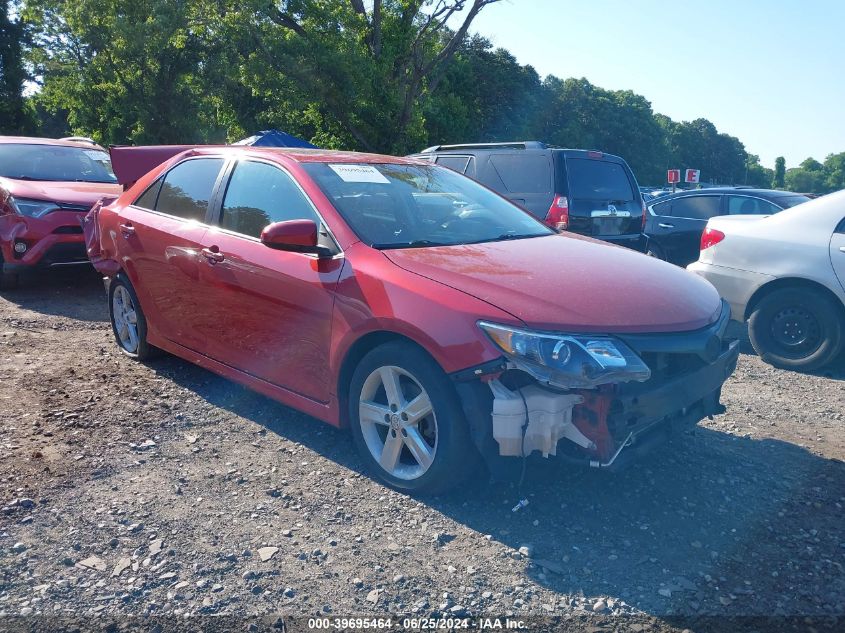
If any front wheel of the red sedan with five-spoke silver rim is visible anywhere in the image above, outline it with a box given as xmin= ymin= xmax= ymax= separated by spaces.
xmin=349 ymin=342 xmax=475 ymax=494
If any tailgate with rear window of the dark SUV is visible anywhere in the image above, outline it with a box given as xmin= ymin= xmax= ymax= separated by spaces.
xmin=566 ymin=155 xmax=642 ymax=239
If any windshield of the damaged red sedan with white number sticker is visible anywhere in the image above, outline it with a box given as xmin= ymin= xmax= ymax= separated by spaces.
xmin=304 ymin=163 xmax=554 ymax=248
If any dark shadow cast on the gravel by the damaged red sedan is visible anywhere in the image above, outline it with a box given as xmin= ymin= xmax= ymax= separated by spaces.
xmin=148 ymin=357 xmax=845 ymax=615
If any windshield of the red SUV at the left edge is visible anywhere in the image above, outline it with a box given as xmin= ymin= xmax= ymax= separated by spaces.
xmin=0 ymin=143 xmax=117 ymax=183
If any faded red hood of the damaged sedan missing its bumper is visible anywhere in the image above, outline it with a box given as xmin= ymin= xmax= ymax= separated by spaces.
xmin=383 ymin=234 xmax=721 ymax=333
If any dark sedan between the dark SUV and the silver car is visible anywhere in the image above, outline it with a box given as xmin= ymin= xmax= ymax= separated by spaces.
xmin=644 ymin=187 xmax=809 ymax=266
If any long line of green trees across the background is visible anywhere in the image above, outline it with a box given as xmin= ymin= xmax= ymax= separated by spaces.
xmin=0 ymin=0 xmax=845 ymax=193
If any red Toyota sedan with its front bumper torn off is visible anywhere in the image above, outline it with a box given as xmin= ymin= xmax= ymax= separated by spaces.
xmin=86 ymin=147 xmax=737 ymax=492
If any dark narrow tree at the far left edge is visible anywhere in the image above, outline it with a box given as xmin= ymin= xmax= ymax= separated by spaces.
xmin=0 ymin=0 xmax=32 ymax=134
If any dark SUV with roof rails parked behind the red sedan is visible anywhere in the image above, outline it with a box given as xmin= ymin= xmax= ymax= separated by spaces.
xmin=413 ymin=141 xmax=645 ymax=251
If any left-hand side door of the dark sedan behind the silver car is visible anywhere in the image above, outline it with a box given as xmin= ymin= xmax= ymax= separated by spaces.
xmin=658 ymin=194 xmax=722 ymax=266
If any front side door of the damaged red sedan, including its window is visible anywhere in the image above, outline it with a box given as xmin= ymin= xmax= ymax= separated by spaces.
xmin=202 ymin=160 xmax=343 ymax=402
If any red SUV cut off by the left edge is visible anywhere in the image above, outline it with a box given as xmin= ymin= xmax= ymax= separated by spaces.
xmin=0 ymin=136 xmax=121 ymax=288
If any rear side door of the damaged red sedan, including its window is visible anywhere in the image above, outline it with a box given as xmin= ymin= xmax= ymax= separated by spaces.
xmin=115 ymin=158 xmax=224 ymax=351
